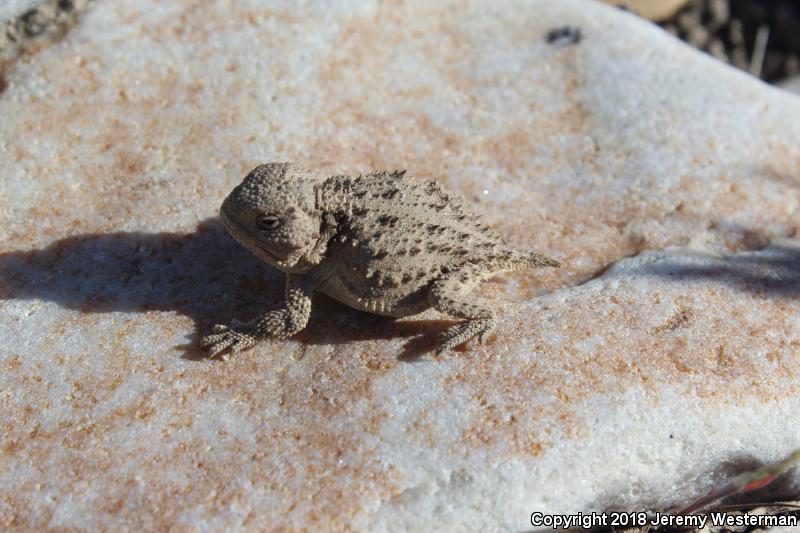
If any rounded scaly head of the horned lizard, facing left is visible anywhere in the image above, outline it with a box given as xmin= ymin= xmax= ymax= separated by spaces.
xmin=219 ymin=163 xmax=322 ymax=273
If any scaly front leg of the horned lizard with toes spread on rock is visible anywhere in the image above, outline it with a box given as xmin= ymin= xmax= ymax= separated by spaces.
xmin=202 ymin=274 xmax=314 ymax=356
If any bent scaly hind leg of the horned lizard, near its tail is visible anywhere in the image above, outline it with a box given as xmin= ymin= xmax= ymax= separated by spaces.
xmin=429 ymin=272 xmax=495 ymax=355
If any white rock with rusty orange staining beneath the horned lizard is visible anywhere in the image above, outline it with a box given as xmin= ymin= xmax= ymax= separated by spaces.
xmin=0 ymin=0 xmax=800 ymax=531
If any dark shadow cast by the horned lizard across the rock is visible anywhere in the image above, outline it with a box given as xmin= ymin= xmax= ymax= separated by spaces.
xmin=0 ymin=218 xmax=451 ymax=361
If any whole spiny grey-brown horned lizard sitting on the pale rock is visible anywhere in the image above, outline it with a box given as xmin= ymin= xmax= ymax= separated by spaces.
xmin=203 ymin=163 xmax=559 ymax=355
